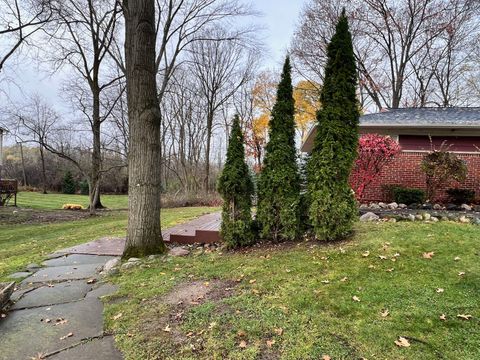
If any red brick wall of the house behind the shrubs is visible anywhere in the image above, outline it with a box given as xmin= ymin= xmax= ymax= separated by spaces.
xmin=356 ymin=152 xmax=480 ymax=203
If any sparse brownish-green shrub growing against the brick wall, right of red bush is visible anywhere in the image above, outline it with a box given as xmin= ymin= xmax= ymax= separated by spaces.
xmin=422 ymin=145 xmax=468 ymax=201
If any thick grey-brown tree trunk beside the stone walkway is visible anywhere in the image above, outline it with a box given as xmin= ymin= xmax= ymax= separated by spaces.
xmin=123 ymin=0 xmax=165 ymax=258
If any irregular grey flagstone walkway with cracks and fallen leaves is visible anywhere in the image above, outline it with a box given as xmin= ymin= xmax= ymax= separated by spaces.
xmin=0 ymin=254 xmax=122 ymax=360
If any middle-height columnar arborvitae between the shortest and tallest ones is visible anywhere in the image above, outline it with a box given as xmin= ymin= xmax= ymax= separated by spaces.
xmin=257 ymin=57 xmax=300 ymax=241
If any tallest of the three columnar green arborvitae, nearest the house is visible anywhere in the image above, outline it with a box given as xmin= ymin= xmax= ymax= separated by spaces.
xmin=307 ymin=10 xmax=360 ymax=240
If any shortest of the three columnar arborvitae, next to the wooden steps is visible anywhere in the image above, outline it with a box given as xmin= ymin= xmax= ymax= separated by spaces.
xmin=218 ymin=115 xmax=254 ymax=248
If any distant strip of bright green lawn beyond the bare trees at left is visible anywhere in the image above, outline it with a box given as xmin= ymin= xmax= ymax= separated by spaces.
xmin=17 ymin=191 xmax=128 ymax=210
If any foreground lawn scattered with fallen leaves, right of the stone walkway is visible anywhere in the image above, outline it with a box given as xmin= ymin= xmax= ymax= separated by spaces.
xmin=105 ymin=222 xmax=480 ymax=360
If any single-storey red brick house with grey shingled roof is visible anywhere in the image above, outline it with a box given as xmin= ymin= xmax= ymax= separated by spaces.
xmin=302 ymin=107 xmax=480 ymax=202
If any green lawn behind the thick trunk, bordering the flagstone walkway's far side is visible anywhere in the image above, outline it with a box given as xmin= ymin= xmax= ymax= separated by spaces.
xmin=0 ymin=205 xmax=217 ymax=280
